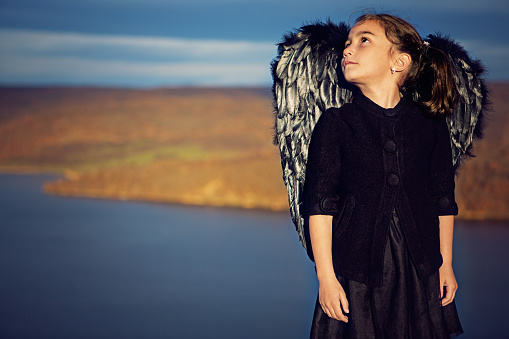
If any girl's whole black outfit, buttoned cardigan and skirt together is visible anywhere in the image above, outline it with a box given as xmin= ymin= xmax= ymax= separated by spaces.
xmin=305 ymin=93 xmax=463 ymax=339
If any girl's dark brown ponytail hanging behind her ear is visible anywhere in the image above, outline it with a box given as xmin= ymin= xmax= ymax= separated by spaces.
xmin=414 ymin=42 xmax=459 ymax=116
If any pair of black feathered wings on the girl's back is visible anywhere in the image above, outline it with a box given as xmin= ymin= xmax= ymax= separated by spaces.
xmin=272 ymin=22 xmax=489 ymax=254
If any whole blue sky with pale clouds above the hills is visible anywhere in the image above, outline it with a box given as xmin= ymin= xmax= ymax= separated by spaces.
xmin=0 ymin=0 xmax=509 ymax=88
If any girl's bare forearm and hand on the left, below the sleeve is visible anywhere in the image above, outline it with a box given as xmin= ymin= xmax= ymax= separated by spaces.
xmin=309 ymin=215 xmax=349 ymax=322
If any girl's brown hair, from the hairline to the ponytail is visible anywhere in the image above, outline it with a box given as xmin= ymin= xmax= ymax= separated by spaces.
xmin=355 ymin=14 xmax=458 ymax=115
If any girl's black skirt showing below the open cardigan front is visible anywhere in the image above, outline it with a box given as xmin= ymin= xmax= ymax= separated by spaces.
xmin=311 ymin=213 xmax=463 ymax=339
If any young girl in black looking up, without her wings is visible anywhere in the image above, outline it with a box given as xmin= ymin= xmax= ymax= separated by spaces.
xmin=304 ymin=14 xmax=462 ymax=339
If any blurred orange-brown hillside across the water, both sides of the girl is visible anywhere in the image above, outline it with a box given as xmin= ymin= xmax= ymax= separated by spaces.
xmin=0 ymin=84 xmax=509 ymax=220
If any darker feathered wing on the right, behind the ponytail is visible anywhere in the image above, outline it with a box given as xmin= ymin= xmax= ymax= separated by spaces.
xmin=426 ymin=34 xmax=490 ymax=169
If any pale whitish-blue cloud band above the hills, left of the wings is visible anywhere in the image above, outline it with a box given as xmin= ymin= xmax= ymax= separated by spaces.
xmin=0 ymin=30 xmax=276 ymax=86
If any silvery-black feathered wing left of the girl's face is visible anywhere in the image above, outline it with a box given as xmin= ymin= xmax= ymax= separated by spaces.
xmin=272 ymin=22 xmax=352 ymax=254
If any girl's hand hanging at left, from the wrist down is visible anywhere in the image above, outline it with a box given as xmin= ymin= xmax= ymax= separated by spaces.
xmin=318 ymin=277 xmax=349 ymax=323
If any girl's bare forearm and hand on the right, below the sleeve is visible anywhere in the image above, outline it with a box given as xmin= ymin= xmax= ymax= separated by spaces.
xmin=439 ymin=215 xmax=458 ymax=306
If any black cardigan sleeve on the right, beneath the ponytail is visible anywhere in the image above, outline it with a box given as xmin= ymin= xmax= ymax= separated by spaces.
xmin=430 ymin=117 xmax=458 ymax=215
